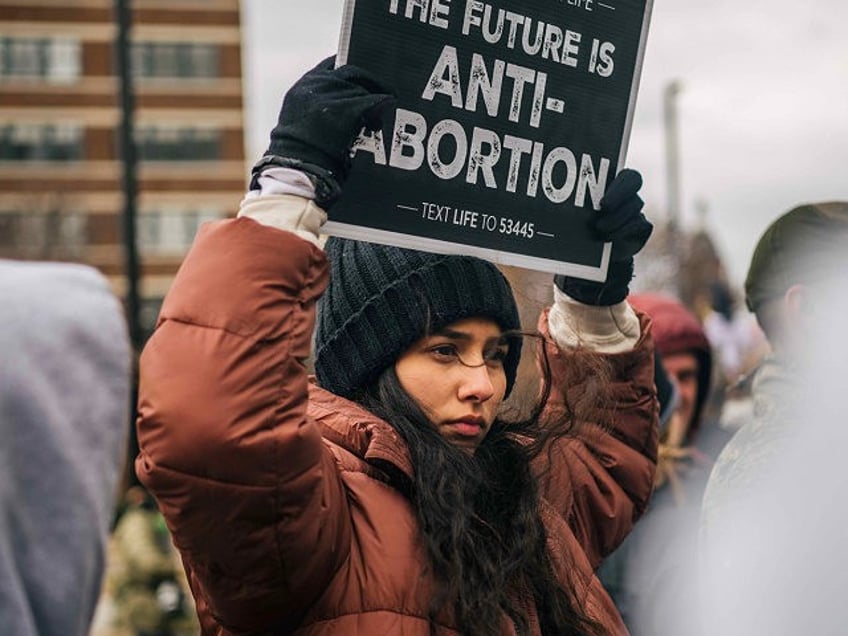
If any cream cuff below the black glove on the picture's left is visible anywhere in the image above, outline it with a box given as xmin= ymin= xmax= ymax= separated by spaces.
xmin=238 ymin=194 xmax=327 ymax=247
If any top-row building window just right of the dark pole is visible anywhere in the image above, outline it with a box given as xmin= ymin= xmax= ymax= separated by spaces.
xmin=131 ymin=42 xmax=220 ymax=78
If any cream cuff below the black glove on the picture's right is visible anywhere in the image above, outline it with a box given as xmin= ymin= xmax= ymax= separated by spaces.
xmin=548 ymin=285 xmax=641 ymax=353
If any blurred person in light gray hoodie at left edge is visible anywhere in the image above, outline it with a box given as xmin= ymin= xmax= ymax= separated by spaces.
xmin=0 ymin=260 xmax=131 ymax=636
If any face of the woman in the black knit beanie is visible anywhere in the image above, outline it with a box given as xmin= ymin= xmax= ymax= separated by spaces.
xmin=395 ymin=318 xmax=509 ymax=452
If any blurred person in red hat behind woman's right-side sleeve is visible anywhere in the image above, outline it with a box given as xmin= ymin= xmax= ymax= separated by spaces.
xmin=599 ymin=292 xmax=726 ymax=636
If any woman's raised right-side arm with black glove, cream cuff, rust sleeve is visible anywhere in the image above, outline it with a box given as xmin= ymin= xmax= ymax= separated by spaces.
xmin=537 ymin=170 xmax=658 ymax=567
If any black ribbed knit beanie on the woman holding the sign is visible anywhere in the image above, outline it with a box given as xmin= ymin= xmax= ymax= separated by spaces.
xmin=315 ymin=237 xmax=521 ymax=398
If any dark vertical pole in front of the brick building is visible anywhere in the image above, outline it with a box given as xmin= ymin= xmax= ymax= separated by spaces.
xmin=115 ymin=0 xmax=142 ymax=351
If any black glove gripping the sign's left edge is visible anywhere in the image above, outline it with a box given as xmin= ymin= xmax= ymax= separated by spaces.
xmin=250 ymin=56 xmax=396 ymax=207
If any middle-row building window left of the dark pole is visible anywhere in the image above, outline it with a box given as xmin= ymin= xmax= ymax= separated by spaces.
xmin=0 ymin=124 xmax=83 ymax=161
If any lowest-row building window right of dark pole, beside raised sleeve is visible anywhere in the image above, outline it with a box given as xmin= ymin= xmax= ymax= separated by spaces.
xmin=136 ymin=210 xmax=223 ymax=255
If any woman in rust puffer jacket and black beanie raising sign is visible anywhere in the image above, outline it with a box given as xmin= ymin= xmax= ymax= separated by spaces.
xmin=136 ymin=61 xmax=656 ymax=635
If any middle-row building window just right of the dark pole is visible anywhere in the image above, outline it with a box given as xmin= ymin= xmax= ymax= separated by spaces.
xmin=136 ymin=127 xmax=221 ymax=161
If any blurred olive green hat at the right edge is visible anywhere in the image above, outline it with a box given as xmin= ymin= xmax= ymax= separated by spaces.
xmin=745 ymin=201 xmax=848 ymax=312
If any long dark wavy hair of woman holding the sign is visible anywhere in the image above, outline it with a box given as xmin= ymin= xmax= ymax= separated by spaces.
xmin=359 ymin=332 xmax=603 ymax=636
